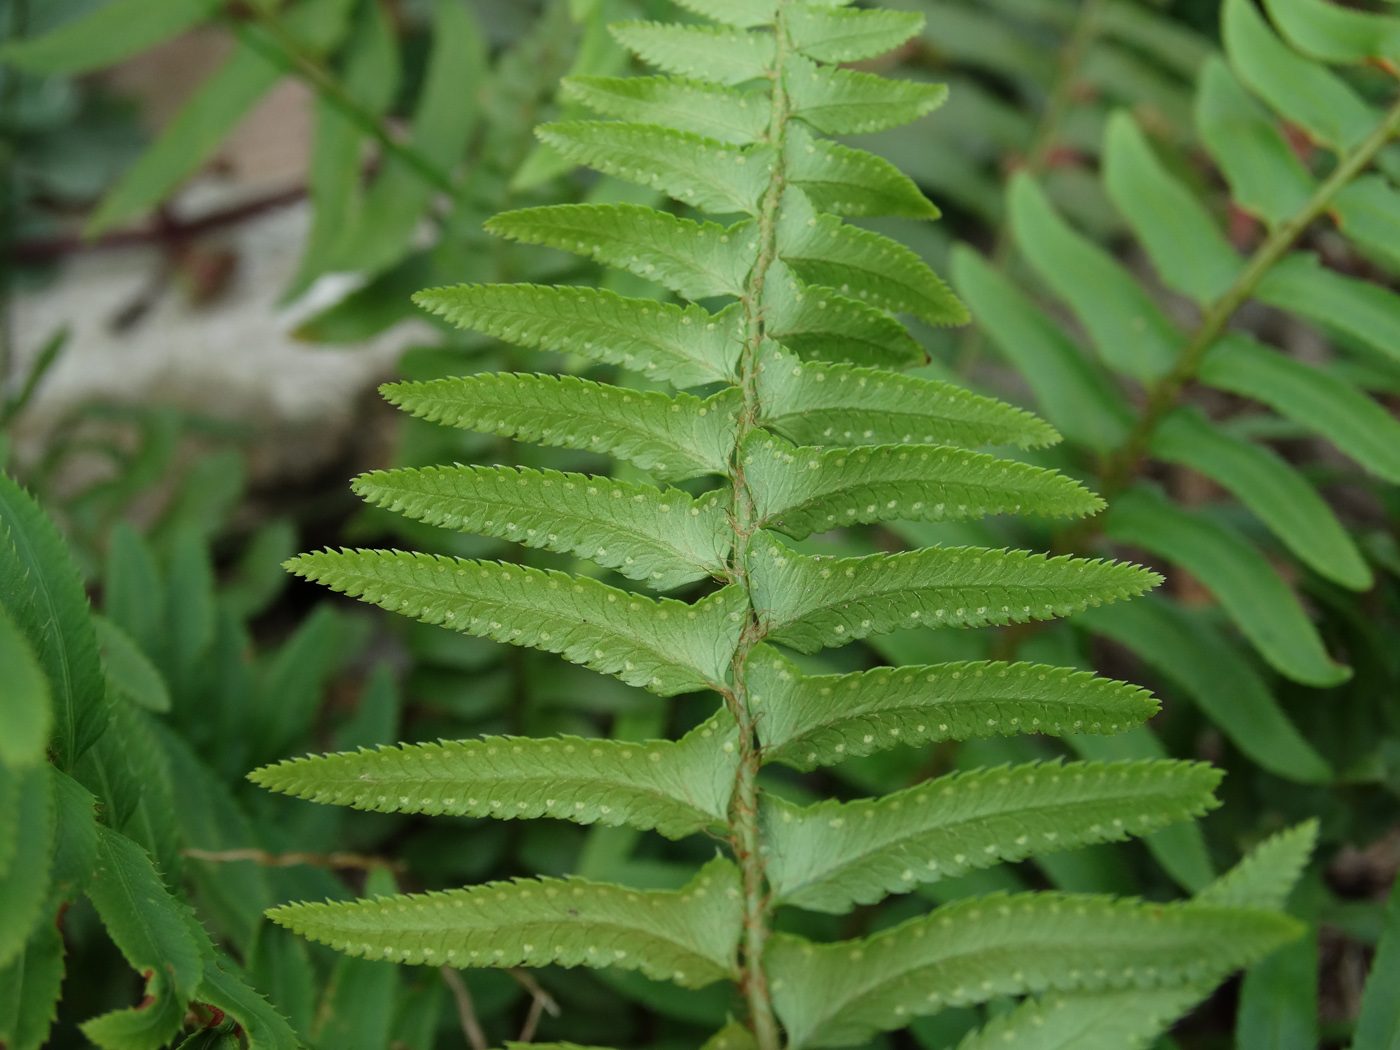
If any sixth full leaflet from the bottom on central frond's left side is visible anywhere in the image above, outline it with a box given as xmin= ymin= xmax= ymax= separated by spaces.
xmin=413 ymin=284 xmax=743 ymax=386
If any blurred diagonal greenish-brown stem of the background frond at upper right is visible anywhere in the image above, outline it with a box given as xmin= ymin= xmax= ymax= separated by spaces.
xmin=1056 ymin=88 xmax=1400 ymax=560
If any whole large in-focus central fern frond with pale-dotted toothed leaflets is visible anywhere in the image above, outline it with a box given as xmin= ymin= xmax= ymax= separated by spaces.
xmin=255 ymin=0 xmax=1310 ymax=1050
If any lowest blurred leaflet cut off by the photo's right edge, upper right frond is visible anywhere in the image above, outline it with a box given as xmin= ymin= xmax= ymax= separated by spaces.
xmin=1200 ymin=333 xmax=1400 ymax=484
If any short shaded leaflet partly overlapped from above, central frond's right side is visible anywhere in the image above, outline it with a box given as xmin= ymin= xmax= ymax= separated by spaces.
xmin=763 ymin=259 xmax=928 ymax=368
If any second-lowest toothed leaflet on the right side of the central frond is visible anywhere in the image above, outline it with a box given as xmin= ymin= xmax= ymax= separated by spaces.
xmin=762 ymin=762 xmax=1222 ymax=913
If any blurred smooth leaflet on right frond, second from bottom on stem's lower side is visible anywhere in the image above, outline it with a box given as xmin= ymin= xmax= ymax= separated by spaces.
xmin=1105 ymin=486 xmax=1351 ymax=687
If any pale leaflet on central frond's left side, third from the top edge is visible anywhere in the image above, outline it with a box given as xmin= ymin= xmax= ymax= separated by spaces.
xmin=561 ymin=77 xmax=770 ymax=146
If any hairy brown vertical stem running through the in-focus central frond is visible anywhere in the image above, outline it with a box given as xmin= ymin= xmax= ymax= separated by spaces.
xmin=727 ymin=4 xmax=788 ymax=1050
